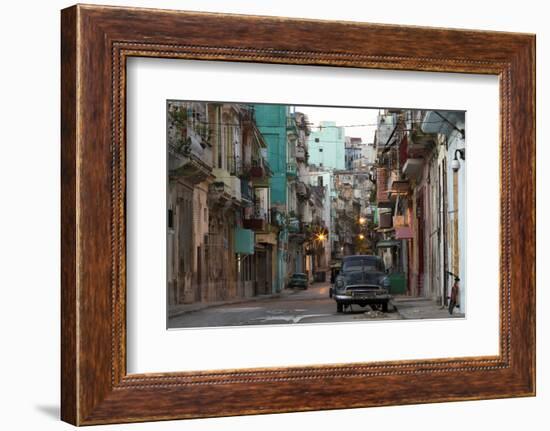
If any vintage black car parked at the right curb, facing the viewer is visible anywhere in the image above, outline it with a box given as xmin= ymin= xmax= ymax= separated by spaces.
xmin=330 ymin=255 xmax=391 ymax=313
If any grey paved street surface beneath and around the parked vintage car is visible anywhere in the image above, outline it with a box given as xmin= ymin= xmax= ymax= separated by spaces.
xmin=169 ymin=283 xmax=460 ymax=328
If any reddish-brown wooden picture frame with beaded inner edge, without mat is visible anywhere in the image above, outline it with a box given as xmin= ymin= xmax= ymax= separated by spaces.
xmin=61 ymin=5 xmax=535 ymax=425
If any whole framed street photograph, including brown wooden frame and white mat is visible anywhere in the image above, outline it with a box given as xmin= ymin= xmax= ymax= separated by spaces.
xmin=61 ymin=5 xmax=535 ymax=425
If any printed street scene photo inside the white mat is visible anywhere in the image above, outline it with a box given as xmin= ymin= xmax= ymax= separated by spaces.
xmin=165 ymin=100 xmax=467 ymax=328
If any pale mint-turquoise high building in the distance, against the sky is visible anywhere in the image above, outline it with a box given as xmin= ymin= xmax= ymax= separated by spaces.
xmin=308 ymin=121 xmax=346 ymax=169
